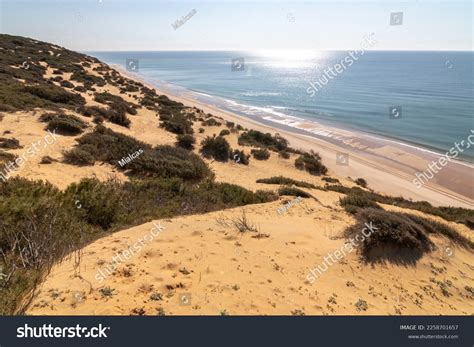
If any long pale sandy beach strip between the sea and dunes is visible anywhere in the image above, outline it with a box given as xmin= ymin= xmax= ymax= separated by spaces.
xmin=115 ymin=64 xmax=474 ymax=208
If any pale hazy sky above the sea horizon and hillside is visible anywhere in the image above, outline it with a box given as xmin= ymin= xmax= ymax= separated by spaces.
xmin=0 ymin=0 xmax=473 ymax=51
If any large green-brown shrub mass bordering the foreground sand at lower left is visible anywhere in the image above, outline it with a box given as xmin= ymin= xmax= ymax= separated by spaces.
xmin=0 ymin=174 xmax=275 ymax=314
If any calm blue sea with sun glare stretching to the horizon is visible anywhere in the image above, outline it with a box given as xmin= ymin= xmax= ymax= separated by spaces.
xmin=88 ymin=51 xmax=474 ymax=162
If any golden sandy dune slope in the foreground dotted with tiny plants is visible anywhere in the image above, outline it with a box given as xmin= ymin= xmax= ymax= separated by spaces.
xmin=28 ymin=201 xmax=474 ymax=315
